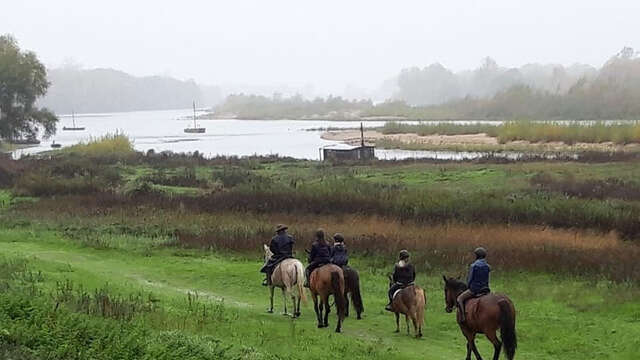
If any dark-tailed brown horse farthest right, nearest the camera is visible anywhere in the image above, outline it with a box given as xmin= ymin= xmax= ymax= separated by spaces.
xmin=442 ymin=275 xmax=518 ymax=360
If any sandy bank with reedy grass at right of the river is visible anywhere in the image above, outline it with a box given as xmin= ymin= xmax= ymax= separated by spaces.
xmin=322 ymin=129 xmax=640 ymax=152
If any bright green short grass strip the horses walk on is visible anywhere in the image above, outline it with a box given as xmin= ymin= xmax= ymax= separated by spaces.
xmin=0 ymin=228 xmax=640 ymax=359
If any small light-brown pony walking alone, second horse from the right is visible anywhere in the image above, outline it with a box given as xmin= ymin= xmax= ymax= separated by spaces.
xmin=389 ymin=275 xmax=427 ymax=338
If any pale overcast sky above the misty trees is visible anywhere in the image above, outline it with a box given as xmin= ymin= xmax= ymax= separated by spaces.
xmin=0 ymin=0 xmax=640 ymax=93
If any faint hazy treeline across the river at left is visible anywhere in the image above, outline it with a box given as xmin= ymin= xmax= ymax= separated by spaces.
xmin=39 ymin=67 xmax=221 ymax=113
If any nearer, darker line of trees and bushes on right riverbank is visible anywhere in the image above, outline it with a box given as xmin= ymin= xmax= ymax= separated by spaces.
xmin=216 ymin=48 xmax=640 ymax=120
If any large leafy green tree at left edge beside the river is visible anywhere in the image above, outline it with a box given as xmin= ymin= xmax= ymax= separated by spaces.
xmin=0 ymin=35 xmax=58 ymax=140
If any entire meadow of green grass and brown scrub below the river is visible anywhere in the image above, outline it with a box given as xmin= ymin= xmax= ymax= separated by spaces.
xmin=0 ymin=143 xmax=640 ymax=360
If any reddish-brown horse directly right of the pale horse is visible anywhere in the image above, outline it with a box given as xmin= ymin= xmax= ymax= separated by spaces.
xmin=309 ymin=264 xmax=346 ymax=332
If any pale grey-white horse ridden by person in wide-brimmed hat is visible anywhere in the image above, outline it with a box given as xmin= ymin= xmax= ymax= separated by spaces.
xmin=264 ymin=245 xmax=306 ymax=318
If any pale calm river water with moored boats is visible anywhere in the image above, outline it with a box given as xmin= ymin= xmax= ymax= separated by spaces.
xmin=13 ymin=109 xmax=604 ymax=160
